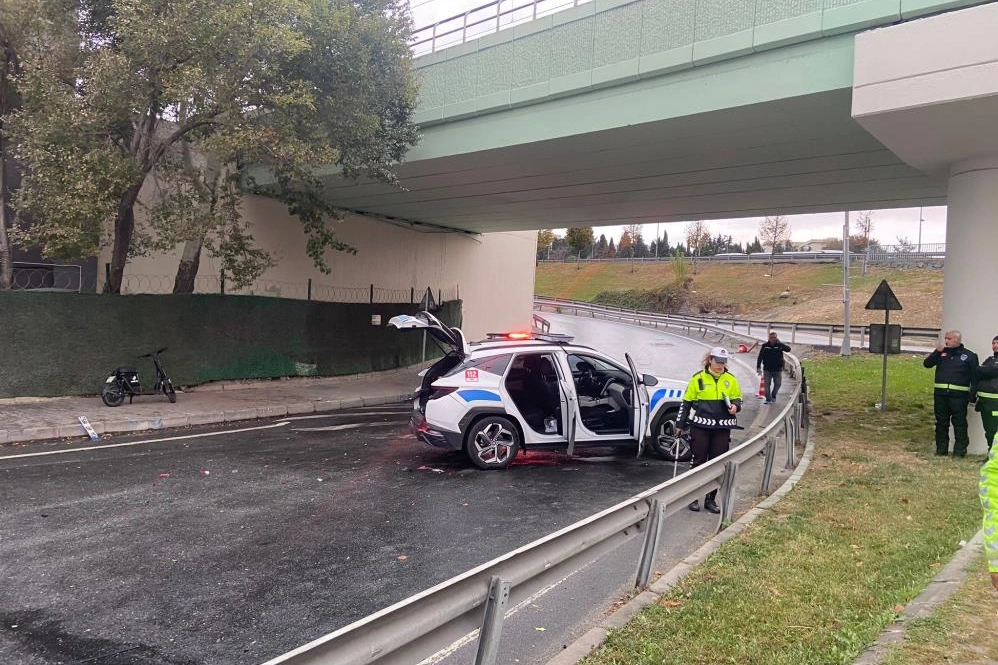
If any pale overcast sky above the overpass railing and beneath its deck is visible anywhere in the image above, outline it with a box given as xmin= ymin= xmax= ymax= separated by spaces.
xmin=409 ymin=0 xmax=946 ymax=245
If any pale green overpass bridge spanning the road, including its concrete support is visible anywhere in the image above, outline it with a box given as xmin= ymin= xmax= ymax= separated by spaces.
xmin=302 ymin=0 xmax=998 ymax=452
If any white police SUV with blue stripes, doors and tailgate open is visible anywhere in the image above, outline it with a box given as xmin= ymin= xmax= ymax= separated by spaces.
xmin=388 ymin=312 xmax=690 ymax=469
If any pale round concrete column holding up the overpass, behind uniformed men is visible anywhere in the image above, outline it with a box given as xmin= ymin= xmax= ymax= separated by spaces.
xmin=943 ymin=155 xmax=998 ymax=454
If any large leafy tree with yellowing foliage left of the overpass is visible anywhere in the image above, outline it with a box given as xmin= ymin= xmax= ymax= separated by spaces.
xmin=15 ymin=0 xmax=417 ymax=293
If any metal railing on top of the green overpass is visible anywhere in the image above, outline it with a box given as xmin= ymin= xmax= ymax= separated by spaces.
xmin=409 ymin=0 xmax=592 ymax=56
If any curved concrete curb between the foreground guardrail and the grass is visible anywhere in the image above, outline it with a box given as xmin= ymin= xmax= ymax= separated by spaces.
xmin=547 ymin=412 xmax=814 ymax=665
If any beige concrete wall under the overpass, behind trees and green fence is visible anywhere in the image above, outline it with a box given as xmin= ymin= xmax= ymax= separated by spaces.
xmin=101 ymin=191 xmax=537 ymax=339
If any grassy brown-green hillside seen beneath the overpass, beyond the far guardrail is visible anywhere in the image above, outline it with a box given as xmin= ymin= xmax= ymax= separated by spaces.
xmin=534 ymin=261 xmax=943 ymax=328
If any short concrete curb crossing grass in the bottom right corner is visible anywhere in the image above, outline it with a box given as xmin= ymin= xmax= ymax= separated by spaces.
xmin=853 ymin=531 xmax=984 ymax=665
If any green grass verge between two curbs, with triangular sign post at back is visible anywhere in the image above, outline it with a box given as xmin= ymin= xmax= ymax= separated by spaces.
xmin=584 ymin=355 xmax=987 ymax=665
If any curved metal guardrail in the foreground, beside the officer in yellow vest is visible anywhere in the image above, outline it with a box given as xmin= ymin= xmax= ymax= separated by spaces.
xmin=265 ymin=304 xmax=807 ymax=665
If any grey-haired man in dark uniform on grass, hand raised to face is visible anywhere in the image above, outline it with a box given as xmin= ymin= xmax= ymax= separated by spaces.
xmin=922 ymin=330 xmax=978 ymax=457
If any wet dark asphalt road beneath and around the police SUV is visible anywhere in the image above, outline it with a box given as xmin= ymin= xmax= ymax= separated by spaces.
xmin=0 ymin=315 xmax=772 ymax=665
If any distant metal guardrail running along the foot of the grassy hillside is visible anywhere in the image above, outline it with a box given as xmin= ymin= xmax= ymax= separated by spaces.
xmin=534 ymin=297 xmax=940 ymax=350
